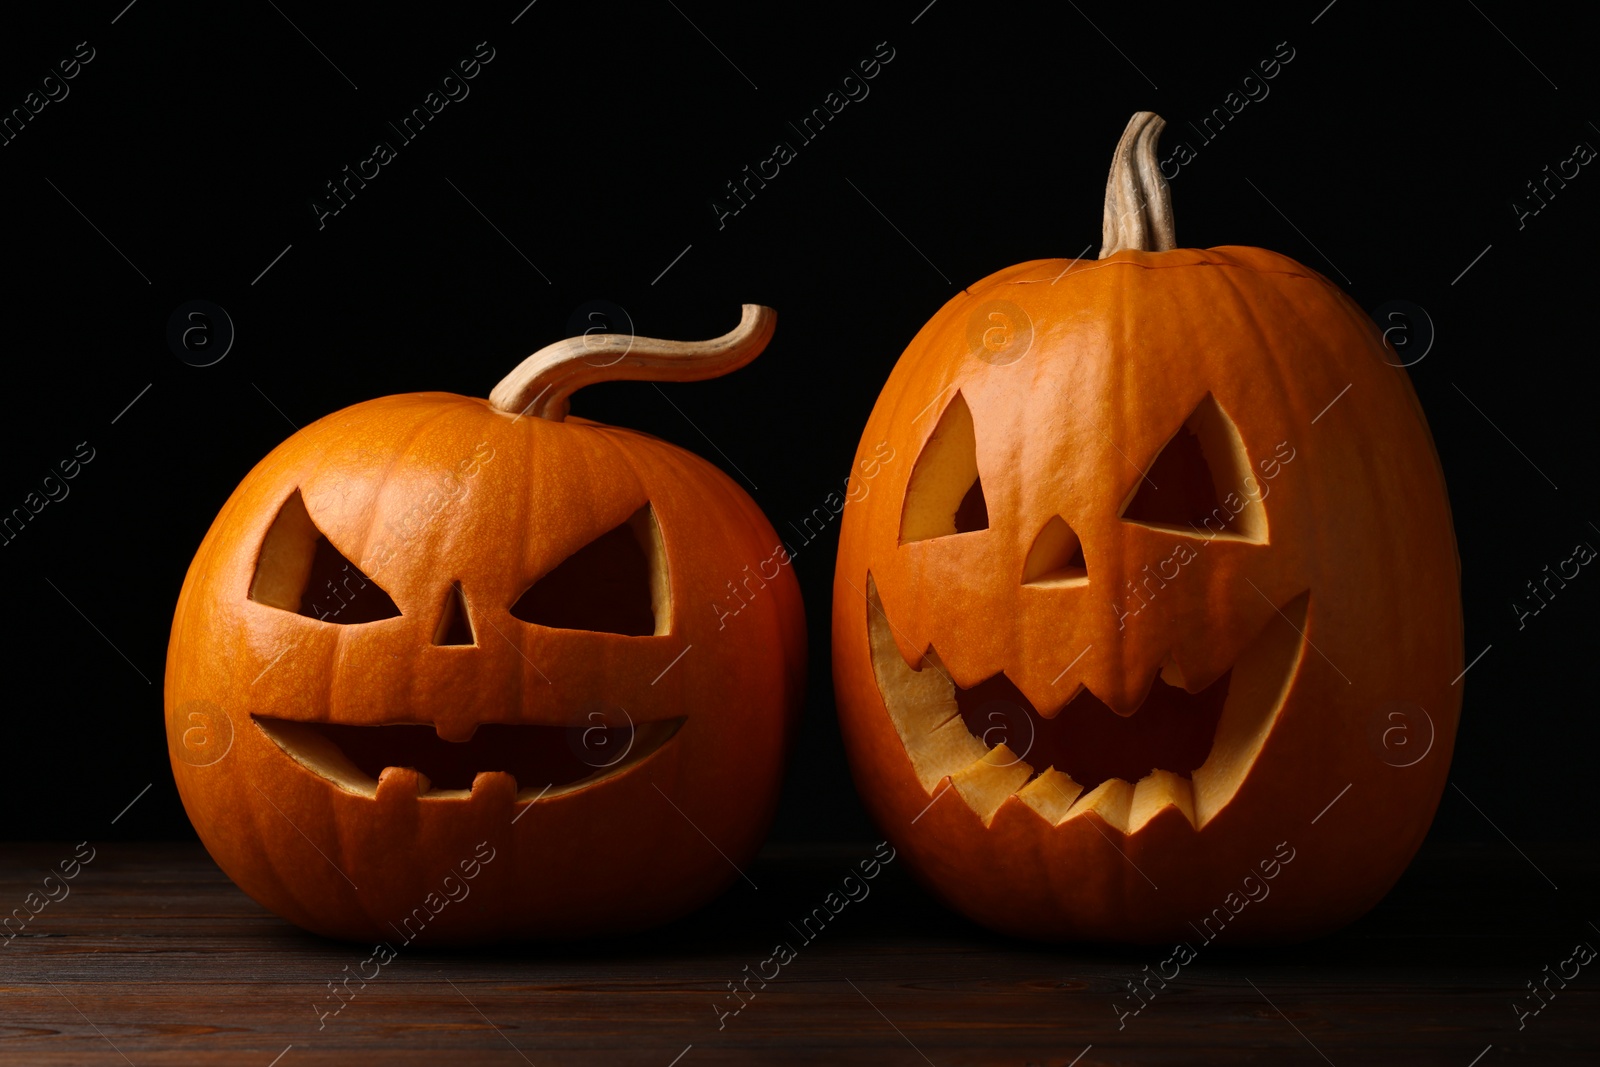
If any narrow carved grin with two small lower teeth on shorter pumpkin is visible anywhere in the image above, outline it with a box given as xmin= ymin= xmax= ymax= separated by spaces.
xmin=251 ymin=715 xmax=683 ymax=800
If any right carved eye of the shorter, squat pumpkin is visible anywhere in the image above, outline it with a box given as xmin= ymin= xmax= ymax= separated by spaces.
xmin=510 ymin=504 xmax=672 ymax=637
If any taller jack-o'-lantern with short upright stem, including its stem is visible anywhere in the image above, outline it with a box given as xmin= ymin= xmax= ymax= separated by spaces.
xmin=834 ymin=114 xmax=1462 ymax=942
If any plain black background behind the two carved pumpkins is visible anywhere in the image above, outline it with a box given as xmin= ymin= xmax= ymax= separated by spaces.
xmin=0 ymin=0 xmax=1600 ymax=841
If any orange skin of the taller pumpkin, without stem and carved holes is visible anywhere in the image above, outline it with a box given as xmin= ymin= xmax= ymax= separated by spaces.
xmin=834 ymin=248 xmax=1462 ymax=945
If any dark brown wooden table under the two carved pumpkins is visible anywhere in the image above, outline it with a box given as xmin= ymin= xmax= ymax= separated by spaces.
xmin=0 ymin=840 xmax=1600 ymax=1067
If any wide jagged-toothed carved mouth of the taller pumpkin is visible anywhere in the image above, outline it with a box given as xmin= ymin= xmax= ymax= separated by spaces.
xmin=866 ymin=573 xmax=1310 ymax=833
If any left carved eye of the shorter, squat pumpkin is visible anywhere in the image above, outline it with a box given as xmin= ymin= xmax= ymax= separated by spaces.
xmin=250 ymin=490 xmax=400 ymax=625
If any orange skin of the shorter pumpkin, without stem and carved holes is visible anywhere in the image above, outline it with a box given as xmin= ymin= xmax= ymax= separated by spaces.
xmin=166 ymin=394 xmax=805 ymax=945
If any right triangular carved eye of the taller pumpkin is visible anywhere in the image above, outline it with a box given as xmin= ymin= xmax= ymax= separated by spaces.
xmin=1122 ymin=394 xmax=1267 ymax=544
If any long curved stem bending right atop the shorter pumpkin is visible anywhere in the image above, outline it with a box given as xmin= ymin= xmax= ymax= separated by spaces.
xmin=490 ymin=304 xmax=778 ymax=422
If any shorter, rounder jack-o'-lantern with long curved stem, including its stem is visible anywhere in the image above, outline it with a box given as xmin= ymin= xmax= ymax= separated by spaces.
xmin=166 ymin=306 xmax=805 ymax=945
